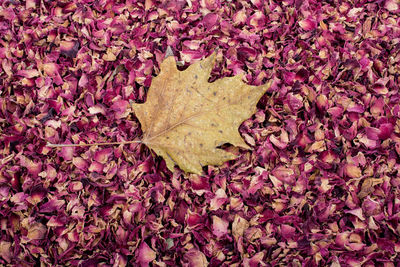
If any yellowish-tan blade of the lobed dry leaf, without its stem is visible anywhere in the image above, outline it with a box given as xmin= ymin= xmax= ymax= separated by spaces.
xmin=132 ymin=53 xmax=269 ymax=174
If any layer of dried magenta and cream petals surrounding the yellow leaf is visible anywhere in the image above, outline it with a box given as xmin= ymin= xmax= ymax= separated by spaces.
xmin=0 ymin=0 xmax=400 ymax=266
